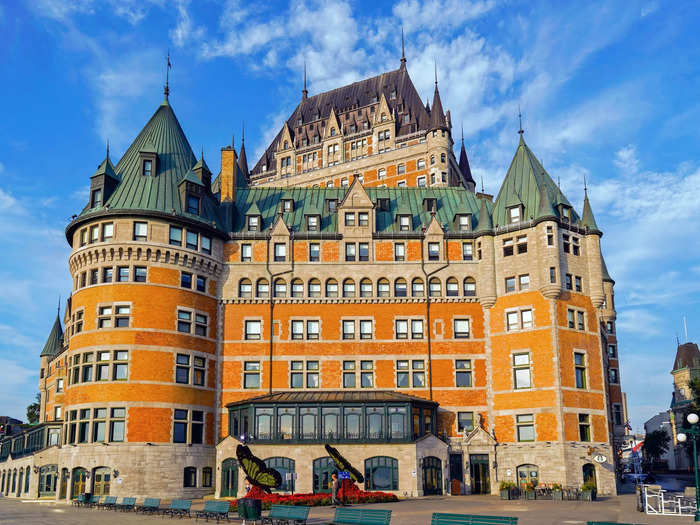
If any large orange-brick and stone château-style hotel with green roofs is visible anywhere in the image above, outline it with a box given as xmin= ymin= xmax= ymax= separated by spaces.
xmin=0 ymin=54 xmax=625 ymax=500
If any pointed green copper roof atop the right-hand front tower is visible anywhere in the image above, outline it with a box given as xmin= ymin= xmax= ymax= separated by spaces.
xmin=493 ymin=135 xmax=578 ymax=226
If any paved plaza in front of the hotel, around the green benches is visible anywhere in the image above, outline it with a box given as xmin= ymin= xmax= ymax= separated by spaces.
xmin=0 ymin=494 xmax=693 ymax=525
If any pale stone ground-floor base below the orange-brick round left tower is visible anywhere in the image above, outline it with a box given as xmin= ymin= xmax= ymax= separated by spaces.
xmin=0 ymin=443 xmax=216 ymax=500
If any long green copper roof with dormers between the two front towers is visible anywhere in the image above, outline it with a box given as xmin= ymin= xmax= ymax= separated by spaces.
xmin=232 ymin=187 xmax=480 ymax=233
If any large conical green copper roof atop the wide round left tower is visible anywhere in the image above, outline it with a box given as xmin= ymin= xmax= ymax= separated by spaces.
xmin=80 ymin=101 xmax=227 ymax=231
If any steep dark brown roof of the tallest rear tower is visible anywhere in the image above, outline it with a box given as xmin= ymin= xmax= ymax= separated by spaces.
xmin=250 ymin=67 xmax=426 ymax=174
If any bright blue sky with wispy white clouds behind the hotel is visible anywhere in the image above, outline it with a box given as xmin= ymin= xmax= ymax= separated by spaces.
xmin=0 ymin=0 xmax=700 ymax=430
